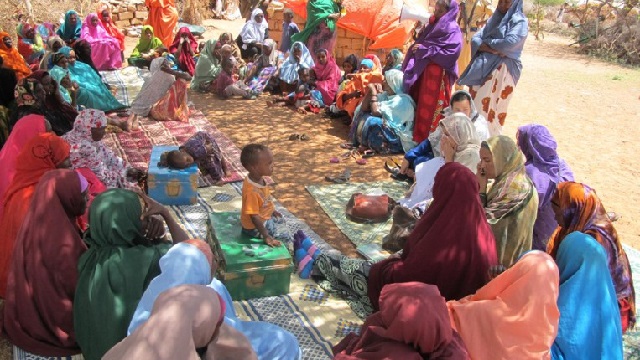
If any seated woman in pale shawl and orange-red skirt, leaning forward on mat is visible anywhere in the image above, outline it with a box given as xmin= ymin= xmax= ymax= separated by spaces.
xmin=127 ymin=53 xmax=191 ymax=126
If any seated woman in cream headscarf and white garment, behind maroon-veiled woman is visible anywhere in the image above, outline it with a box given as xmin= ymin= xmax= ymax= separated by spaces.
xmin=398 ymin=113 xmax=480 ymax=208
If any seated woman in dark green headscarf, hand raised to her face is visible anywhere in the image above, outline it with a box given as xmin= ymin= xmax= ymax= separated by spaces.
xmin=73 ymin=189 xmax=188 ymax=360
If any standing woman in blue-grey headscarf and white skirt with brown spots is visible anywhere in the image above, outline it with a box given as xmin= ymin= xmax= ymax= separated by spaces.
xmin=458 ymin=0 xmax=529 ymax=136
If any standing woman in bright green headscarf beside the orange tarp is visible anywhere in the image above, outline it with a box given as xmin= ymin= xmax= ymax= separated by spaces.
xmin=291 ymin=0 xmax=341 ymax=63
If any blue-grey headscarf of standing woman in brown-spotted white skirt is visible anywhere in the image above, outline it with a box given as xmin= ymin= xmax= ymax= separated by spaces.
xmin=458 ymin=0 xmax=529 ymax=86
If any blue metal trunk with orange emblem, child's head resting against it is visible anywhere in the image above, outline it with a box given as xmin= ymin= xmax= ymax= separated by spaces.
xmin=147 ymin=146 xmax=200 ymax=205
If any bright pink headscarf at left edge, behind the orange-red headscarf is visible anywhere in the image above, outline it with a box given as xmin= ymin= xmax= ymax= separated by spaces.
xmin=0 ymin=114 xmax=46 ymax=214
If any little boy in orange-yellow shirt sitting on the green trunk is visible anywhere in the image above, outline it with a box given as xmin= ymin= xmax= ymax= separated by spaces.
xmin=240 ymin=144 xmax=282 ymax=246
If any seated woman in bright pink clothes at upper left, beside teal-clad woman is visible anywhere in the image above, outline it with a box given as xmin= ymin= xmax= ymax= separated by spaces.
xmin=80 ymin=13 xmax=122 ymax=70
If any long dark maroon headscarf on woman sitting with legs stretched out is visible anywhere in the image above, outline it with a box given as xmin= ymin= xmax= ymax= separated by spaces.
xmin=368 ymin=162 xmax=498 ymax=309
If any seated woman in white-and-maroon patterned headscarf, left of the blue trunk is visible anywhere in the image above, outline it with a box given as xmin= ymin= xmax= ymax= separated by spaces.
xmin=64 ymin=109 xmax=140 ymax=188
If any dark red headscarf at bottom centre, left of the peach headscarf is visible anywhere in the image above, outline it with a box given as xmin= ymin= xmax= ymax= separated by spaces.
xmin=333 ymin=282 xmax=470 ymax=360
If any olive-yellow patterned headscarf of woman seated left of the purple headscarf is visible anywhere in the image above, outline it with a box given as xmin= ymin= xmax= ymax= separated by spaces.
xmin=485 ymin=135 xmax=534 ymax=224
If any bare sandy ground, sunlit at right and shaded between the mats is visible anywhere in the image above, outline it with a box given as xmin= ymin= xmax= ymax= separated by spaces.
xmin=0 ymin=16 xmax=640 ymax=359
